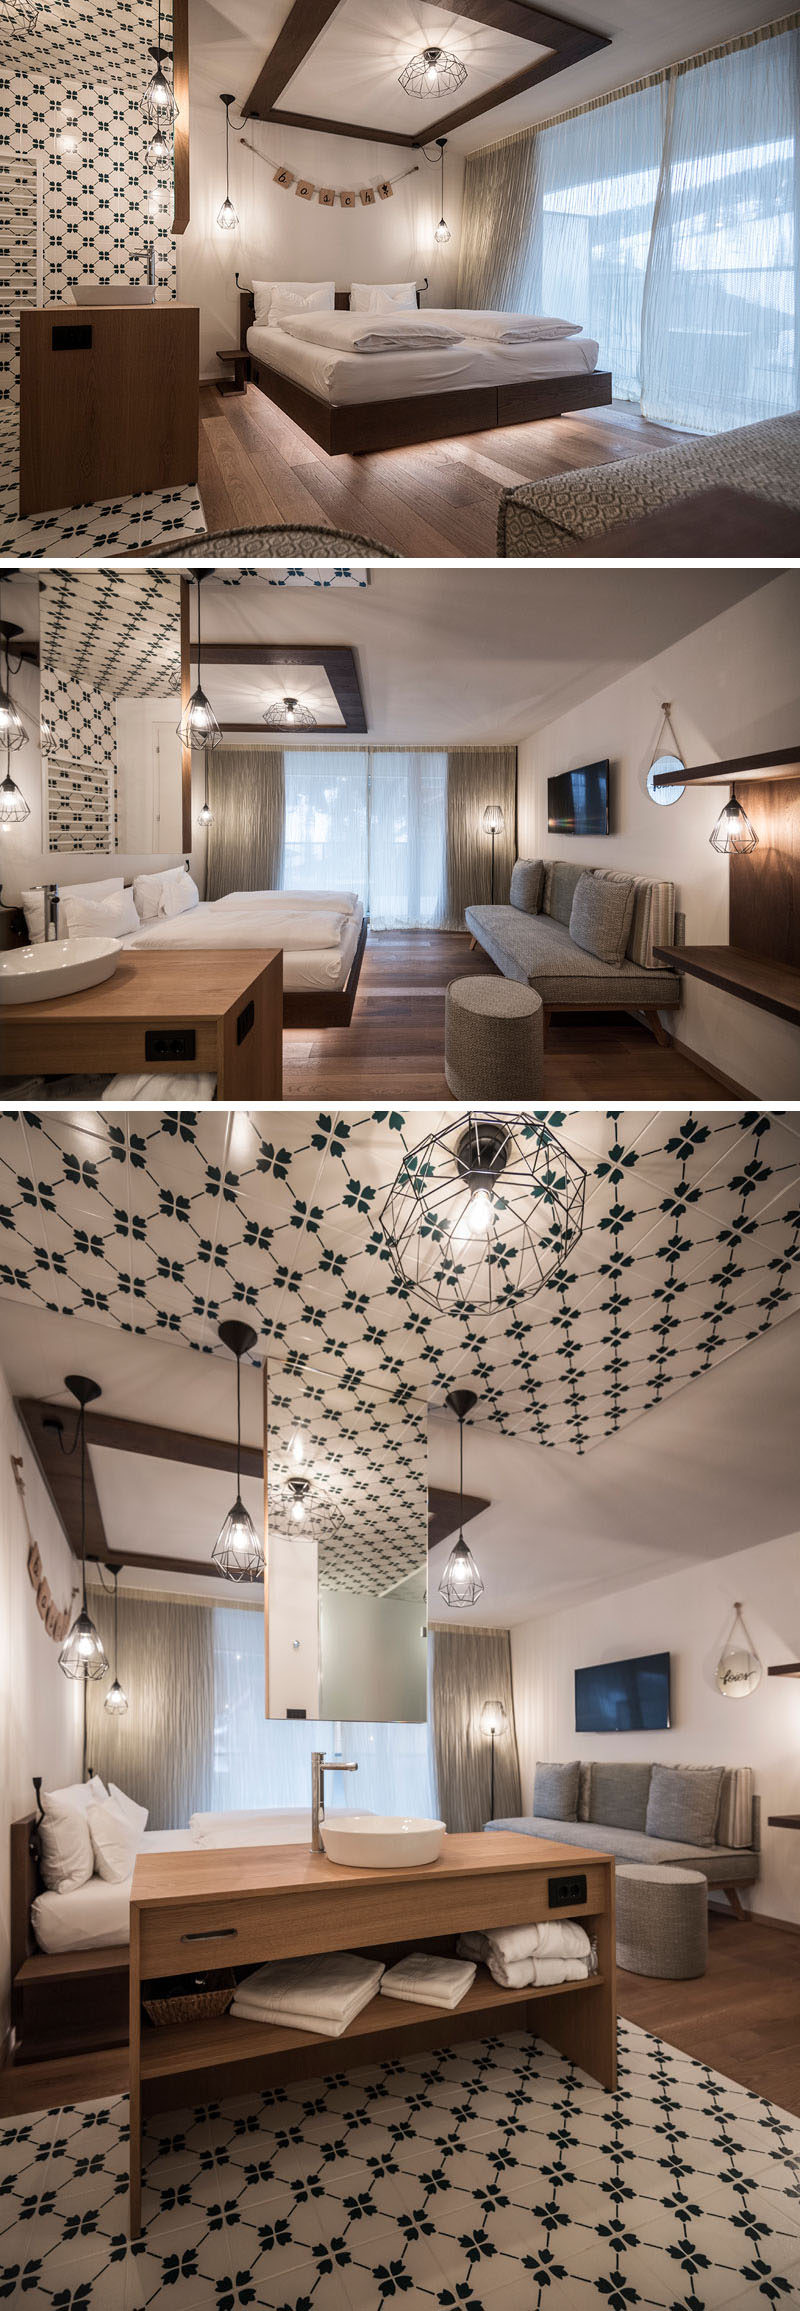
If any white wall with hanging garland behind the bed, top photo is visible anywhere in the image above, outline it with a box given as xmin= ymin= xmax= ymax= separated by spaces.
xmin=178 ymin=104 xmax=462 ymax=377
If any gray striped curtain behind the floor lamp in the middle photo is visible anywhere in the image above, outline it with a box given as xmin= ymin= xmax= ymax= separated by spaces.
xmin=444 ymin=746 xmax=516 ymax=931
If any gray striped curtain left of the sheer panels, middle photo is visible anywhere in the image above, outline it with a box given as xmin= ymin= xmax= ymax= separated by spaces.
xmin=206 ymin=746 xmax=287 ymax=899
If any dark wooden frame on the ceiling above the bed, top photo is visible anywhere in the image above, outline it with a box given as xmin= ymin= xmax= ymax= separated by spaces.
xmin=243 ymin=0 xmax=610 ymax=153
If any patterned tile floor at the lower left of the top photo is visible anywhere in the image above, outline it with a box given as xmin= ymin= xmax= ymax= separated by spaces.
xmin=0 ymin=414 xmax=206 ymax=555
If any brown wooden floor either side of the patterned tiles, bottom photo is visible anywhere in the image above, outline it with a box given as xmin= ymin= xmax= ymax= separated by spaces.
xmin=0 ymin=1914 xmax=800 ymax=2121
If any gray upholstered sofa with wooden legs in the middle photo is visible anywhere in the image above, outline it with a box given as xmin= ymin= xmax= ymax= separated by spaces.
xmin=465 ymin=860 xmax=680 ymax=1042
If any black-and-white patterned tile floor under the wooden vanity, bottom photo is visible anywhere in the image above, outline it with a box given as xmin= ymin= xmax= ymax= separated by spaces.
xmin=0 ymin=2022 xmax=800 ymax=2311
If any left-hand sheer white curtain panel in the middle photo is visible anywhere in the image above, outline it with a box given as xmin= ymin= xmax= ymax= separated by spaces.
xmin=284 ymin=746 xmax=370 ymax=904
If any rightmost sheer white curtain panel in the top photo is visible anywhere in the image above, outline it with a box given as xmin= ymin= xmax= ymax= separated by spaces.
xmin=643 ymin=30 xmax=800 ymax=432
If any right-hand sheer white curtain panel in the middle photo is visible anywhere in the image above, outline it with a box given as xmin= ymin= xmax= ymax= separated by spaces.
xmin=370 ymin=746 xmax=446 ymax=931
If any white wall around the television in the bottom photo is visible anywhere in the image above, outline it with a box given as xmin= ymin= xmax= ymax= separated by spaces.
xmin=511 ymin=1535 xmax=800 ymax=1925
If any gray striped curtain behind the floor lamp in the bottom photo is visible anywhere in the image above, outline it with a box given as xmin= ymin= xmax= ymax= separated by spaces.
xmin=430 ymin=1625 xmax=523 ymax=1830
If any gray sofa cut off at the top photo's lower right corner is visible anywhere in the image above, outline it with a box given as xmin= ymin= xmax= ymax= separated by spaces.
xmin=497 ymin=411 xmax=800 ymax=557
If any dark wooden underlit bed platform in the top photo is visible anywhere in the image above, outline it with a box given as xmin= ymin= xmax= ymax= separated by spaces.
xmin=238 ymin=289 xmax=610 ymax=458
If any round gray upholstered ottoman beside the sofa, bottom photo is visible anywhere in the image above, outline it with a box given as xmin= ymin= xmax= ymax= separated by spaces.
xmin=617 ymin=1863 xmax=708 ymax=1983
